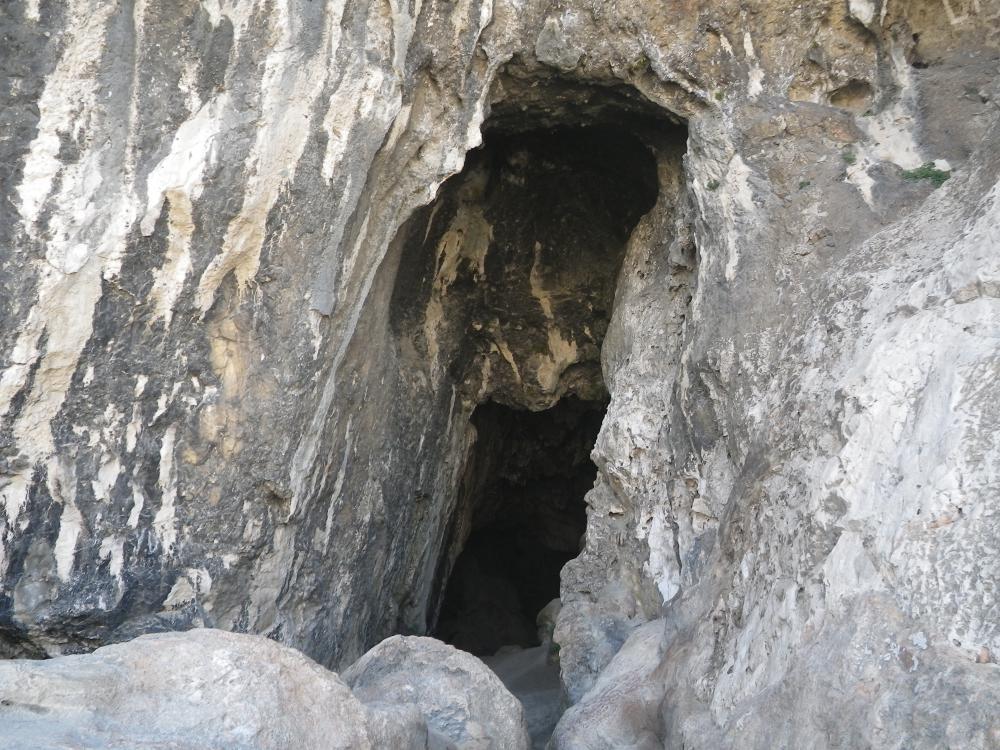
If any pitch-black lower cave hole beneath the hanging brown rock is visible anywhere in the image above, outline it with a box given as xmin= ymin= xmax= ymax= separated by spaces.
xmin=433 ymin=396 xmax=607 ymax=656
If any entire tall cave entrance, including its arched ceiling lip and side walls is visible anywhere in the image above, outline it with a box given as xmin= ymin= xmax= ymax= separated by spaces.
xmin=389 ymin=77 xmax=687 ymax=680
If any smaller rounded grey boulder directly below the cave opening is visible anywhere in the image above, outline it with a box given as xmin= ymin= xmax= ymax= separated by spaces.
xmin=344 ymin=635 xmax=529 ymax=750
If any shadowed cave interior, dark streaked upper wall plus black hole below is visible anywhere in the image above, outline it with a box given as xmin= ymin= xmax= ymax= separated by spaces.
xmin=395 ymin=120 xmax=659 ymax=668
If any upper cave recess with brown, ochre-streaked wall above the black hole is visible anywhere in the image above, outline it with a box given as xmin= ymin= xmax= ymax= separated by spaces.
xmin=391 ymin=125 xmax=659 ymax=418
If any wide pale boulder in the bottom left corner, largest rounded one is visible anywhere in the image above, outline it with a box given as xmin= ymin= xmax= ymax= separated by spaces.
xmin=0 ymin=630 xmax=374 ymax=750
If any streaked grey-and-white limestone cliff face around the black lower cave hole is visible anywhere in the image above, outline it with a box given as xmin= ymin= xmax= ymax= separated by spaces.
xmin=0 ymin=0 xmax=1000 ymax=747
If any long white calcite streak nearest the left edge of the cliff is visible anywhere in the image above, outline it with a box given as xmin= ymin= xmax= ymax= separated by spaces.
xmin=0 ymin=0 xmax=135 ymax=520
